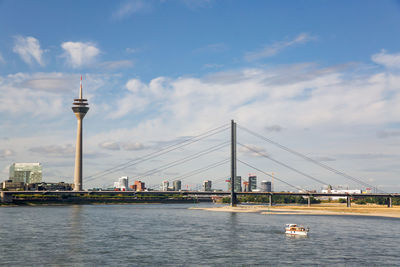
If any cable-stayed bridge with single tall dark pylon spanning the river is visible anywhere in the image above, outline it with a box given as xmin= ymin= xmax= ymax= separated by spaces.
xmin=2 ymin=121 xmax=399 ymax=206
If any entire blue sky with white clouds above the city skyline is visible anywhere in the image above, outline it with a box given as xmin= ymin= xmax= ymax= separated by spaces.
xmin=0 ymin=0 xmax=400 ymax=192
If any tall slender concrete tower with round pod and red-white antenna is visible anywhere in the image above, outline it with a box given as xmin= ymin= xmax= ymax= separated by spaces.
xmin=72 ymin=75 xmax=89 ymax=191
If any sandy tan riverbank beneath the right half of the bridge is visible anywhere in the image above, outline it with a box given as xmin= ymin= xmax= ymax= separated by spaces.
xmin=192 ymin=203 xmax=400 ymax=218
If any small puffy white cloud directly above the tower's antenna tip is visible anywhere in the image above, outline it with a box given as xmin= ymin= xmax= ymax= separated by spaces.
xmin=61 ymin=42 xmax=100 ymax=68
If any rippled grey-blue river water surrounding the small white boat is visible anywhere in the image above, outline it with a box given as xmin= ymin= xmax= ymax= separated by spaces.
xmin=0 ymin=204 xmax=400 ymax=266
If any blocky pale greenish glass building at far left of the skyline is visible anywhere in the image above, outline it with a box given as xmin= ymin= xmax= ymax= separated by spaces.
xmin=9 ymin=163 xmax=42 ymax=184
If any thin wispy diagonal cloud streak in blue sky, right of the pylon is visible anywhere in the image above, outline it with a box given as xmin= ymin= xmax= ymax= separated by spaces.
xmin=245 ymin=33 xmax=315 ymax=61
